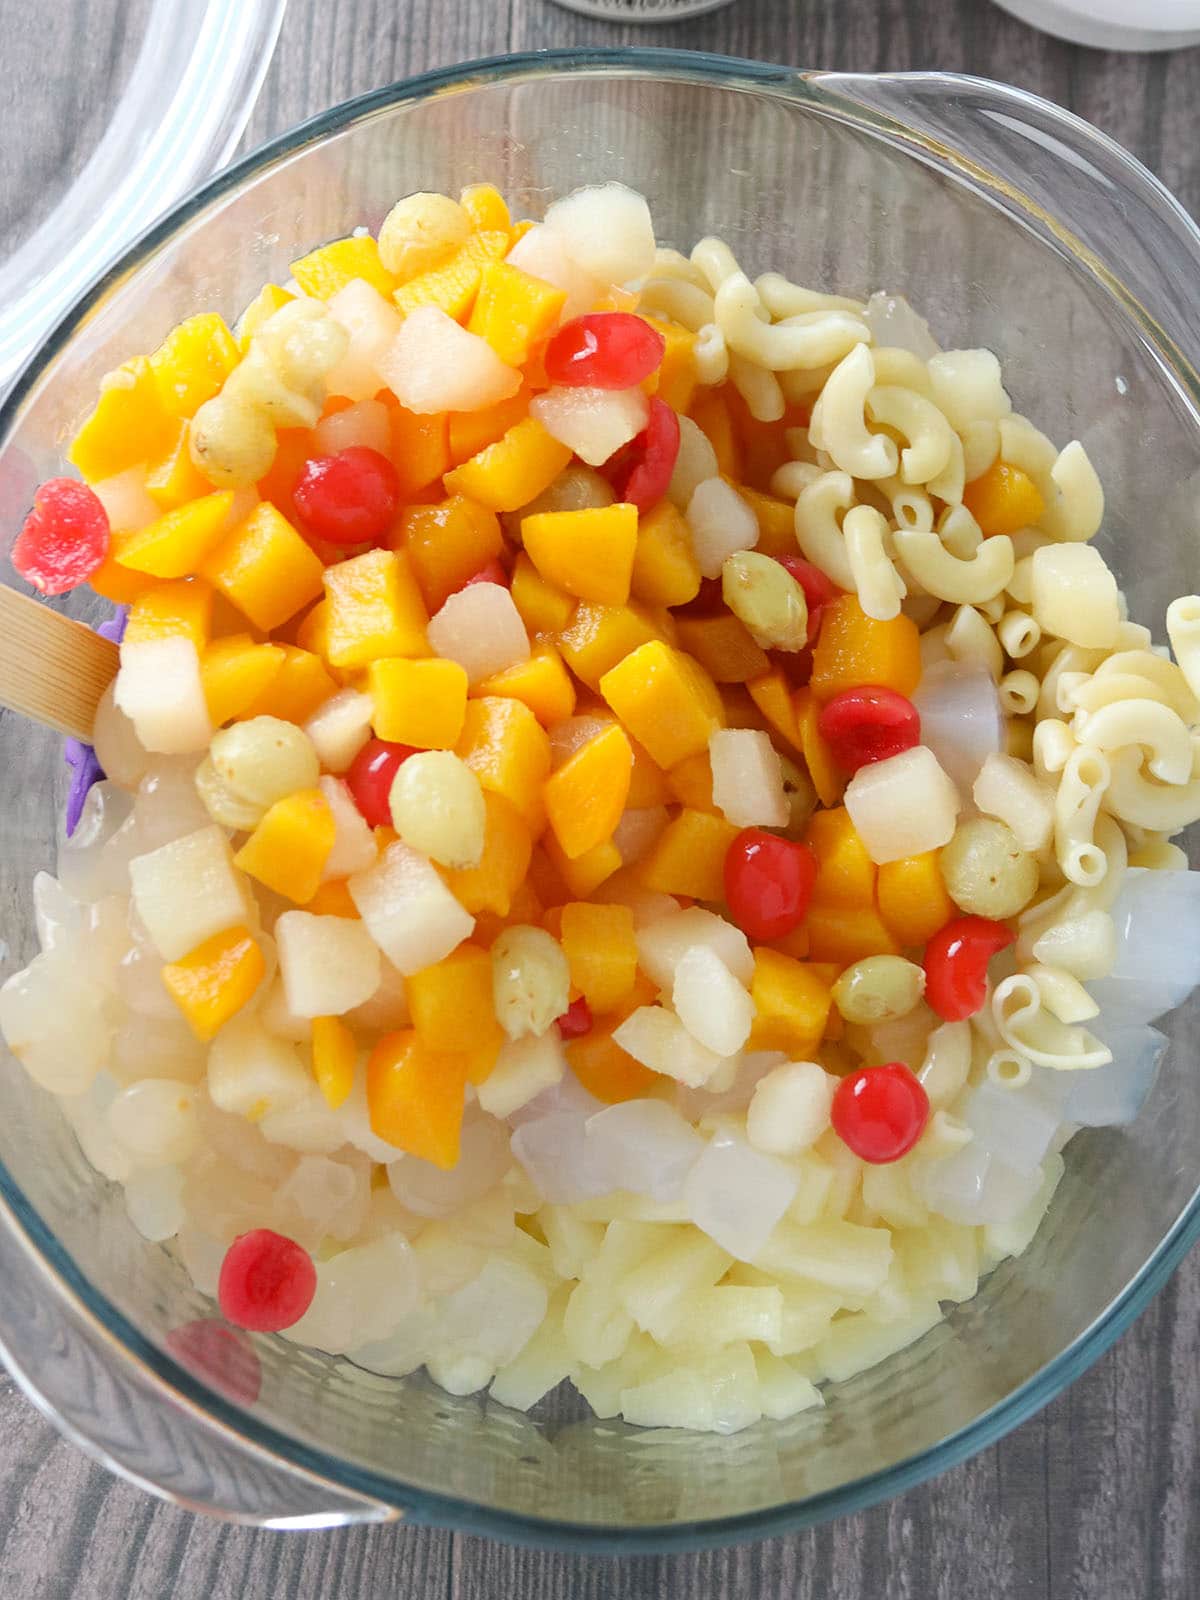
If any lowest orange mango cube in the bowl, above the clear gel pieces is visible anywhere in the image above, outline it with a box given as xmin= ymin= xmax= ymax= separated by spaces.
xmin=366 ymin=1029 xmax=467 ymax=1171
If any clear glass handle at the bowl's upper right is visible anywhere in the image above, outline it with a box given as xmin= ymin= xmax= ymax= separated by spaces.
xmin=808 ymin=72 xmax=1200 ymax=395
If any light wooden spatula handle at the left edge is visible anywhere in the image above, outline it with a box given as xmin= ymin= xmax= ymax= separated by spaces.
xmin=0 ymin=584 xmax=118 ymax=741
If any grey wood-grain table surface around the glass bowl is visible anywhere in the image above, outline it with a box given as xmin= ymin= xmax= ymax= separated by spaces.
xmin=0 ymin=0 xmax=1200 ymax=1600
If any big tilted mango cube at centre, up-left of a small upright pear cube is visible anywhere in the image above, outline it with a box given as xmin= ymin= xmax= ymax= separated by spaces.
xmin=600 ymin=640 xmax=725 ymax=768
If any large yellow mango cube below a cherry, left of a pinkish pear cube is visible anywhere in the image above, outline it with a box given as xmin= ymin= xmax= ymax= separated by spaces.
xmin=325 ymin=550 xmax=429 ymax=670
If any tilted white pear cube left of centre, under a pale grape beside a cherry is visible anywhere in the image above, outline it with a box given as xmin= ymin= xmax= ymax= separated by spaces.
xmin=349 ymin=842 xmax=475 ymax=978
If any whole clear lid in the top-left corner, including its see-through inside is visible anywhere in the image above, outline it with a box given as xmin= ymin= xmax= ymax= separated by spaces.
xmin=0 ymin=0 xmax=286 ymax=392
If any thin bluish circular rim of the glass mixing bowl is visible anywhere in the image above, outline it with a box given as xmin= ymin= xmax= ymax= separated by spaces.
xmin=0 ymin=46 xmax=1200 ymax=1554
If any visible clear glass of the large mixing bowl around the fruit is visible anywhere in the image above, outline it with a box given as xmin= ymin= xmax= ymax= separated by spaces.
xmin=0 ymin=50 xmax=1200 ymax=1550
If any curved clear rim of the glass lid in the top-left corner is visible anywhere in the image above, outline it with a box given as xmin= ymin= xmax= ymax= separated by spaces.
xmin=0 ymin=0 xmax=286 ymax=394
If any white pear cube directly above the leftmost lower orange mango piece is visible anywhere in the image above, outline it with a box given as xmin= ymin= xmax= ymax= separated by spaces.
xmin=130 ymin=827 xmax=253 ymax=962
